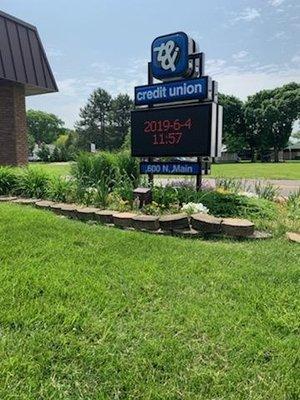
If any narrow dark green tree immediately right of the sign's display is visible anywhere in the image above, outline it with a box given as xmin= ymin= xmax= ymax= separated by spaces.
xmin=219 ymin=94 xmax=247 ymax=152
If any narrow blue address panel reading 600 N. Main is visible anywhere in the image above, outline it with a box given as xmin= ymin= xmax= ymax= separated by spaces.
xmin=140 ymin=161 xmax=209 ymax=175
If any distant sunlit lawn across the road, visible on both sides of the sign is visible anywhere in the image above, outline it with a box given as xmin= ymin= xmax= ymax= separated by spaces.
xmin=30 ymin=162 xmax=300 ymax=179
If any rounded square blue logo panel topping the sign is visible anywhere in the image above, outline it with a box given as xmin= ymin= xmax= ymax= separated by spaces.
xmin=151 ymin=32 xmax=190 ymax=80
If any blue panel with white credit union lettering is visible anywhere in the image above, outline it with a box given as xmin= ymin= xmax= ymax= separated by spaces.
xmin=134 ymin=76 xmax=212 ymax=106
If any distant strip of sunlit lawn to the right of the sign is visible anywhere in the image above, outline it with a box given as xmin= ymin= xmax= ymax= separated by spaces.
xmin=211 ymin=162 xmax=300 ymax=179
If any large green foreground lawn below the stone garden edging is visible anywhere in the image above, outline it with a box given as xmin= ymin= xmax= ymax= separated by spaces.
xmin=0 ymin=204 xmax=300 ymax=400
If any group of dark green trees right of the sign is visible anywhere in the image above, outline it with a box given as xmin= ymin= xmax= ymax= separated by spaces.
xmin=219 ymin=82 xmax=300 ymax=162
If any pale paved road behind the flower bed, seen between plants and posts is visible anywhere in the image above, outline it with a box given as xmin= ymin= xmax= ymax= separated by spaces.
xmin=155 ymin=177 xmax=300 ymax=196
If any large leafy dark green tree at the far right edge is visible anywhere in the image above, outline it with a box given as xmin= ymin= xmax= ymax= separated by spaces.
xmin=245 ymin=83 xmax=300 ymax=162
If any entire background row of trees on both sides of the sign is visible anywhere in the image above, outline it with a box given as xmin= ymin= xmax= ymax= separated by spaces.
xmin=27 ymin=82 xmax=300 ymax=162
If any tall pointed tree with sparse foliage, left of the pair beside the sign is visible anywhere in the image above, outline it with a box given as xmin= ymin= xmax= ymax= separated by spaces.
xmin=76 ymin=88 xmax=112 ymax=150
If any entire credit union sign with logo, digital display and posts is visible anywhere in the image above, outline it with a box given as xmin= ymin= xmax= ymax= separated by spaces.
xmin=131 ymin=32 xmax=223 ymax=190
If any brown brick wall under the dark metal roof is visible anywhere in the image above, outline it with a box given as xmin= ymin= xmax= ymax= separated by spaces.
xmin=0 ymin=82 xmax=28 ymax=165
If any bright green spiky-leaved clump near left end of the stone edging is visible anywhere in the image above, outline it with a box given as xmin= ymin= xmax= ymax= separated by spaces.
xmin=15 ymin=167 xmax=50 ymax=198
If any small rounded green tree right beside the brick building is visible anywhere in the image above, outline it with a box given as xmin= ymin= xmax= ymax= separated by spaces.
xmin=27 ymin=110 xmax=64 ymax=144
